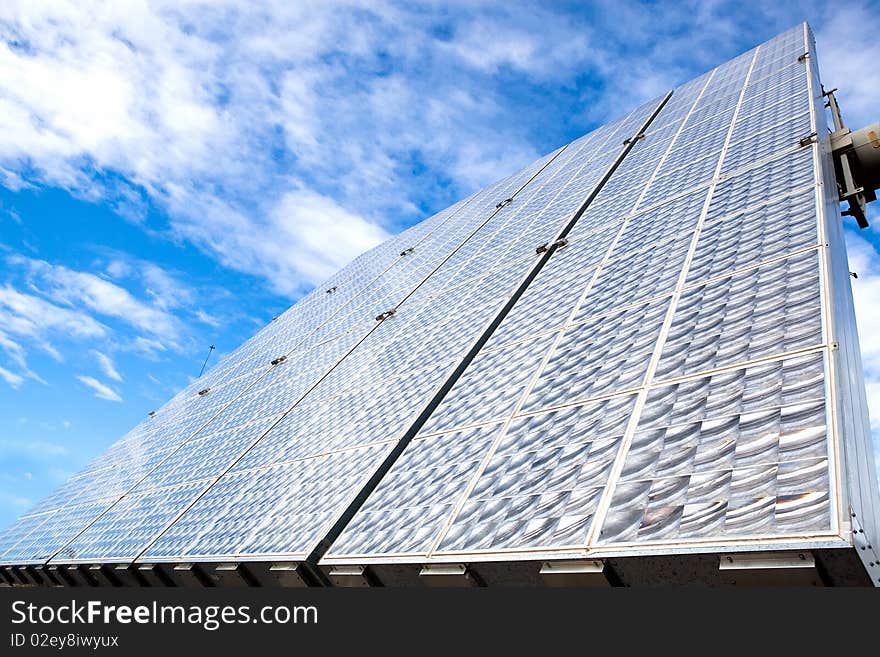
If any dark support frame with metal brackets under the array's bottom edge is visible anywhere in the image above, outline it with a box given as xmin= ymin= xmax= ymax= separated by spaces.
xmin=0 ymin=548 xmax=880 ymax=588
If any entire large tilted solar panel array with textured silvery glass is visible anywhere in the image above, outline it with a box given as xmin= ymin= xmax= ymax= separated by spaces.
xmin=0 ymin=25 xmax=874 ymax=576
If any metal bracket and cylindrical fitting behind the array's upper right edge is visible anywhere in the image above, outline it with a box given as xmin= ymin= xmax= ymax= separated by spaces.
xmin=823 ymin=89 xmax=880 ymax=228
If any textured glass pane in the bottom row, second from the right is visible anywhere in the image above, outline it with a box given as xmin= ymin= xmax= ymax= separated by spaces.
xmin=440 ymin=396 xmax=635 ymax=551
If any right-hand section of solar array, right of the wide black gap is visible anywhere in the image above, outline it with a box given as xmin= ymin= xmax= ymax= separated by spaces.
xmin=323 ymin=27 xmax=871 ymax=576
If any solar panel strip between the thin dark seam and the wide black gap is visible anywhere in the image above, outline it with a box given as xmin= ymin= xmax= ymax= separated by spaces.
xmin=132 ymin=98 xmax=668 ymax=561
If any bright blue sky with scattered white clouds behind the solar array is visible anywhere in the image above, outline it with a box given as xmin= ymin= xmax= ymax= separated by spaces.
xmin=0 ymin=0 xmax=880 ymax=526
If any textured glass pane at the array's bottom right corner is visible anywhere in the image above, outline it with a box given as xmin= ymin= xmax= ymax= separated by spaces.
xmin=600 ymin=353 xmax=830 ymax=543
